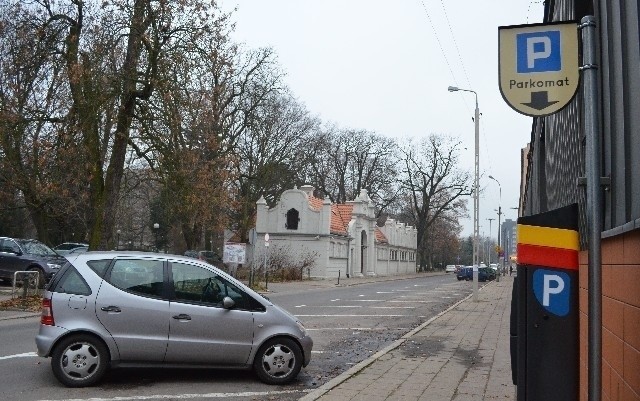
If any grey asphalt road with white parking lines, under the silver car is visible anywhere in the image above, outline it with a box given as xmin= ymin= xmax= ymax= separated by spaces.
xmin=0 ymin=274 xmax=471 ymax=401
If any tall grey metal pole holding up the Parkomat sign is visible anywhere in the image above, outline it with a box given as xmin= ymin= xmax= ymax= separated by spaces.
xmin=580 ymin=15 xmax=602 ymax=401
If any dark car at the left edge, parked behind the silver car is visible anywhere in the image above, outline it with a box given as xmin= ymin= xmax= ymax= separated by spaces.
xmin=0 ymin=237 xmax=67 ymax=287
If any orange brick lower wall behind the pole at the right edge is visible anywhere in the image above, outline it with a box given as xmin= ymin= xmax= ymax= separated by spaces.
xmin=580 ymin=230 xmax=640 ymax=401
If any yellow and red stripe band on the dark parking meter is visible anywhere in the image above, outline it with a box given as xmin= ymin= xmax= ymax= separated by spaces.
xmin=518 ymin=224 xmax=580 ymax=270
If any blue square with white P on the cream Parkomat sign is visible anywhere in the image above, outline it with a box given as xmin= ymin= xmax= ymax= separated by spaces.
xmin=516 ymin=31 xmax=562 ymax=74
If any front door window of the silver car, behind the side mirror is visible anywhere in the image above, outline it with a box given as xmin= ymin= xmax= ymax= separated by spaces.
xmin=171 ymin=263 xmax=248 ymax=309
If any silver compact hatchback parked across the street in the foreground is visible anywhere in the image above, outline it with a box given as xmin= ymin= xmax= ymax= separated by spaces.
xmin=36 ymin=252 xmax=313 ymax=387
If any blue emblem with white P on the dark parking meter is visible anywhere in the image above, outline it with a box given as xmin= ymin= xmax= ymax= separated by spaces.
xmin=533 ymin=269 xmax=571 ymax=316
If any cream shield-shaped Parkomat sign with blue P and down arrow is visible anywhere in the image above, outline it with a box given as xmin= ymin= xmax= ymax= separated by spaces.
xmin=498 ymin=21 xmax=580 ymax=117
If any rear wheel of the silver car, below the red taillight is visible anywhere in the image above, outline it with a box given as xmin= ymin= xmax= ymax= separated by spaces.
xmin=51 ymin=334 xmax=109 ymax=387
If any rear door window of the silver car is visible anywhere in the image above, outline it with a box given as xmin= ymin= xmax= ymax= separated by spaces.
xmin=107 ymin=259 xmax=164 ymax=297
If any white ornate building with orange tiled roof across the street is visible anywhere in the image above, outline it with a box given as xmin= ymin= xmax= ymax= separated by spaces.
xmin=256 ymin=185 xmax=417 ymax=278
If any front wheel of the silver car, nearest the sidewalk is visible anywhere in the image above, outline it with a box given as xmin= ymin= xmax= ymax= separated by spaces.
xmin=253 ymin=337 xmax=302 ymax=384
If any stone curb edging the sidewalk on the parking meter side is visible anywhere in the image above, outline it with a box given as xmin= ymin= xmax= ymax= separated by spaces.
xmin=299 ymin=281 xmax=495 ymax=401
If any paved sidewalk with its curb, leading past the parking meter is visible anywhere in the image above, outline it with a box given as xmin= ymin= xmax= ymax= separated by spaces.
xmin=301 ymin=276 xmax=516 ymax=401
